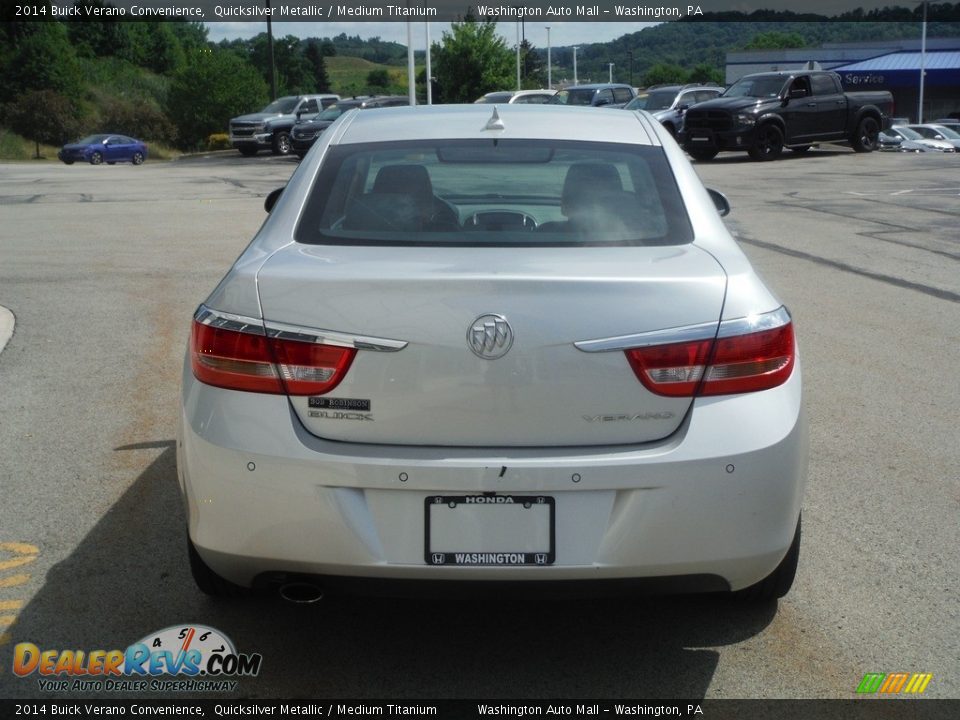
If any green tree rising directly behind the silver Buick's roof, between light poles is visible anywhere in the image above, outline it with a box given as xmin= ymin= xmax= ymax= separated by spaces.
xmin=432 ymin=21 xmax=516 ymax=103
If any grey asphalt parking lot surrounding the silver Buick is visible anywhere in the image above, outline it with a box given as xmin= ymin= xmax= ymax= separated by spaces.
xmin=0 ymin=143 xmax=960 ymax=699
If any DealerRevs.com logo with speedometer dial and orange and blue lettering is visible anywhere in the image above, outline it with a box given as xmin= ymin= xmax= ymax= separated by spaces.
xmin=13 ymin=624 xmax=263 ymax=692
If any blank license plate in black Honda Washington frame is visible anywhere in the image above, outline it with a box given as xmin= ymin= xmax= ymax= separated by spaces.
xmin=424 ymin=495 xmax=556 ymax=567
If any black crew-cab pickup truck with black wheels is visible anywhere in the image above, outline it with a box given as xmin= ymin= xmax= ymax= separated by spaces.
xmin=681 ymin=71 xmax=893 ymax=160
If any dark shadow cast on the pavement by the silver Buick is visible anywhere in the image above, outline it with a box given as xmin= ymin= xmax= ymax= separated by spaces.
xmin=0 ymin=441 xmax=776 ymax=699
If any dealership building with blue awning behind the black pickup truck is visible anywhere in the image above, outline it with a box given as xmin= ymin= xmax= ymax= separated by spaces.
xmin=726 ymin=38 xmax=960 ymax=122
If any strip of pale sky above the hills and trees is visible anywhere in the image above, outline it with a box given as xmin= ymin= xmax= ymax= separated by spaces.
xmin=206 ymin=20 xmax=657 ymax=50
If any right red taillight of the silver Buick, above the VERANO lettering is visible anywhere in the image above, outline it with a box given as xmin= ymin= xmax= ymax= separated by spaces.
xmin=626 ymin=308 xmax=796 ymax=397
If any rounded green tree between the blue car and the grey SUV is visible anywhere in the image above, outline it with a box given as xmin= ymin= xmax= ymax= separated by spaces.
xmin=168 ymin=49 xmax=268 ymax=148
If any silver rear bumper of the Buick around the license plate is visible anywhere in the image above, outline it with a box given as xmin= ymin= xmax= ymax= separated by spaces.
xmin=177 ymin=364 xmax=807 ymax=590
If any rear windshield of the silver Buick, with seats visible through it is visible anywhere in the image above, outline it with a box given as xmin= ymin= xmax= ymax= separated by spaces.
xmin=296 ymin=139 xmax=693 ymax=246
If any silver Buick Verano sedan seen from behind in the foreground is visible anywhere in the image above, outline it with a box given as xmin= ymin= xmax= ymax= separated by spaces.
xmin=177 ymin=105 xmax=807 ymax=601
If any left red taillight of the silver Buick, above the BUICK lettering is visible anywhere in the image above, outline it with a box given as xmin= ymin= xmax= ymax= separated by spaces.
xmin=190 ymin=320 xmax=357 ymax=395
